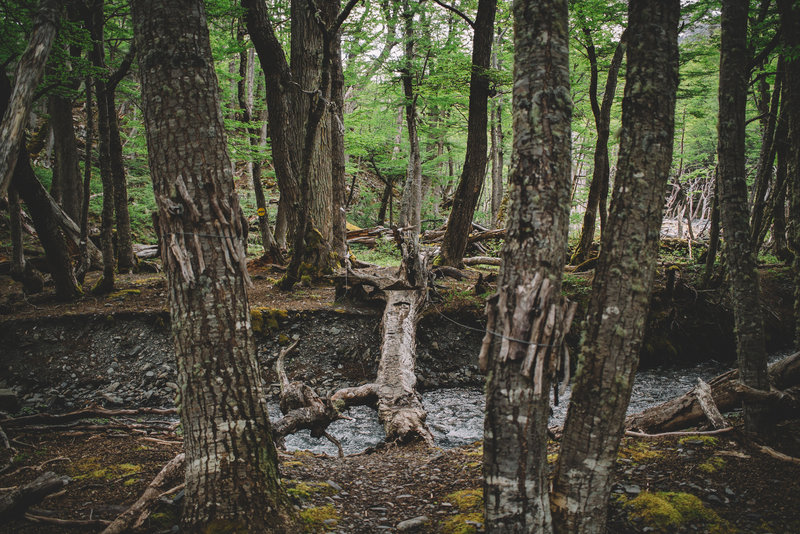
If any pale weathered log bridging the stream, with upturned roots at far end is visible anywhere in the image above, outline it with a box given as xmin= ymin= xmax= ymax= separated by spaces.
xmin=331 ymin=232 xmax=433 ymax=444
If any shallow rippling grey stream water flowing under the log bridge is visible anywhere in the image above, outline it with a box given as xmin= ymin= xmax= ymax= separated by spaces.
xmin=270 ymin=354 xmax=785 ymax=456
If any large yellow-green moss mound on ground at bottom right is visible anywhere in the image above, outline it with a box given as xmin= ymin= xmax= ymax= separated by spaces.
xmin=623 ymin=492 xmax=736 ymax=534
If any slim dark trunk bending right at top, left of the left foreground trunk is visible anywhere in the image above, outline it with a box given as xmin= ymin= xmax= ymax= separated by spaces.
xmin=103 ymin=47 xmax=136 ymax=272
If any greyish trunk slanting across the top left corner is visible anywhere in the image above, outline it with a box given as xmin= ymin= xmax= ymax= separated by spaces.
xmin=0 ymin=0 xmax=61 ymax=197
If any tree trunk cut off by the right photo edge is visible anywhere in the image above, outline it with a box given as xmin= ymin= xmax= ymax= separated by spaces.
xmin=778 ymin=0 xmax=800 ymax=347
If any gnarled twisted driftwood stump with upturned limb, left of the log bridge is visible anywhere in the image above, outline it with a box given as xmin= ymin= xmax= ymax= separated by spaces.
xmin=272 ymin=341 xmax=349 ymax=457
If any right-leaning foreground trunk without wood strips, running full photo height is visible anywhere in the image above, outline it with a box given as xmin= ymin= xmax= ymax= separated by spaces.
xmin=553 ymin=0 xmax=680 ymax=534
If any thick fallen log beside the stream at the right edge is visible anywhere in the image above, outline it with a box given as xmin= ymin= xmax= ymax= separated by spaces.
xmin=625 ymin=352 xmax=800 ymax=433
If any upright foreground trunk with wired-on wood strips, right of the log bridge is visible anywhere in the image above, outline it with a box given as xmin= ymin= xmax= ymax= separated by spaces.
xmin=481 ymin=0 xmax=572 ymax=534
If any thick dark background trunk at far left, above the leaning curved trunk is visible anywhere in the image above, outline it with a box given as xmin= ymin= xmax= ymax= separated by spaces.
xmin=47 ymin=95 xmax=82 ymax=221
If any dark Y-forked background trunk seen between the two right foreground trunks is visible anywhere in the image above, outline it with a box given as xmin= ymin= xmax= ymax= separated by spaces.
xmin=570 ymin=29 xmax=626 ymax=265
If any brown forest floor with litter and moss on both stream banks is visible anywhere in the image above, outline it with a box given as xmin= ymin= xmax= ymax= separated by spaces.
xmin=0 ymin=254 xmax=800 ymax=533
